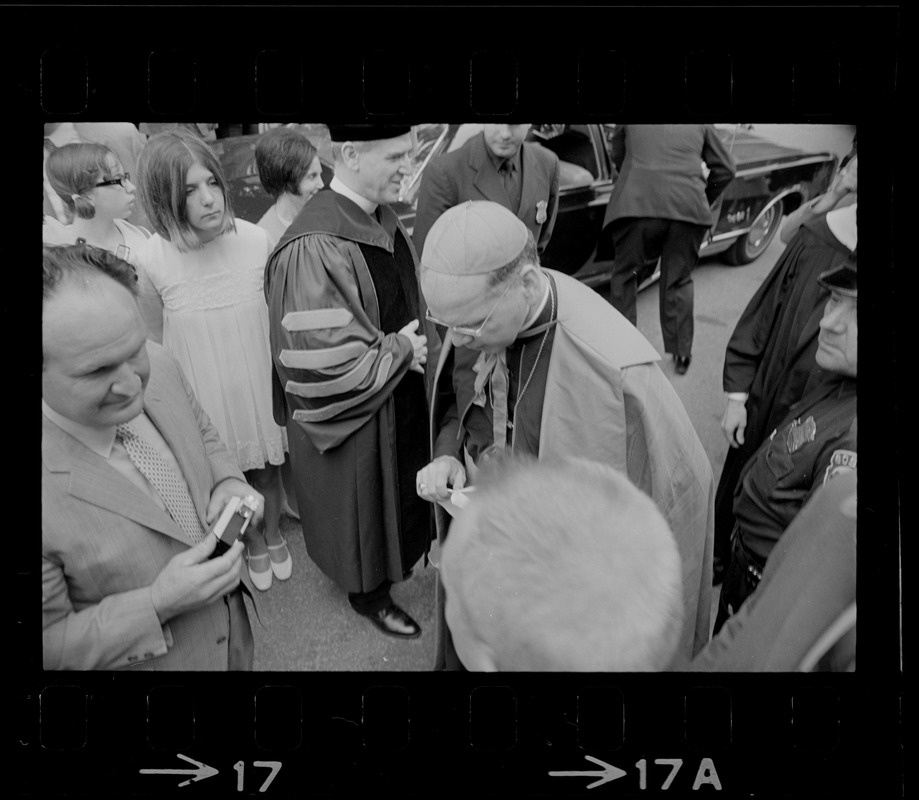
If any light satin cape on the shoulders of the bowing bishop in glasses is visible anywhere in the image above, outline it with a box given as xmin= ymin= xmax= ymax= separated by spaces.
xmin=431 ymin=270 xmax=714 ymax=669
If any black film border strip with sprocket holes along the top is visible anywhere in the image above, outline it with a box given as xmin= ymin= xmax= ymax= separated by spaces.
xmin=20 ymin=5 xmax=899 ymax=122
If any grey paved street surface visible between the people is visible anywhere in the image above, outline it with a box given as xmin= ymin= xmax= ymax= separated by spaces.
xmin=253 ymin=125 xmax=852 ymax=671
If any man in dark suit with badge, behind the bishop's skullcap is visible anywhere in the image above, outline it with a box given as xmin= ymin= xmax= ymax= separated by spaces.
xmin=412 ymin=125 xmax=559 ymax=255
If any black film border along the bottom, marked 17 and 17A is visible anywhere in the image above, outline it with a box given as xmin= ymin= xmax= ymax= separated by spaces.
xmin=20 ymin=675 xmax=898 ymax=797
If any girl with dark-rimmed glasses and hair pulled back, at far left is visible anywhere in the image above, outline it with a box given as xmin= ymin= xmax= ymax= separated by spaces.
xmin=42 ymin=142 xmax=163 ymax=342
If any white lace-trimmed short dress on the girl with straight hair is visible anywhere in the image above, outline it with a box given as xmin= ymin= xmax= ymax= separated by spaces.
xmin=138 ymin=219 xmax=287 ymax=470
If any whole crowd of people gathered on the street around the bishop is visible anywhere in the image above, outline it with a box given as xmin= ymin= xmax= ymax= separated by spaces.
xmin=42 ymin=123 xmax=858 ymax=671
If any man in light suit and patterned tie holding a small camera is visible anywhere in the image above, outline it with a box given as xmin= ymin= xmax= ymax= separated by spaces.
xmin=42 ymin=245 xmax=264 ymax=670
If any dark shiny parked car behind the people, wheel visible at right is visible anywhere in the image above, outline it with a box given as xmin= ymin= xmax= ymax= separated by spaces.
xmin=214 ymin=123 xmax=837 ymax=285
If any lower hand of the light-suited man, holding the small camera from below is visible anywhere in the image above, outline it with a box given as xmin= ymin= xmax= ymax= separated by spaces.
xmin=150 ymin=531 xmax=243 ymax=624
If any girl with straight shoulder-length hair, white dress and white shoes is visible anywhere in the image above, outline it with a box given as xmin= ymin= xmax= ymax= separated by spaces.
xmin=138 ymin=129 xmax=292 ymax=591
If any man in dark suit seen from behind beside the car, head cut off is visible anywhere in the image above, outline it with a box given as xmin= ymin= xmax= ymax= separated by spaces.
xmin=603 ymin=125 xmax=735 ymax=375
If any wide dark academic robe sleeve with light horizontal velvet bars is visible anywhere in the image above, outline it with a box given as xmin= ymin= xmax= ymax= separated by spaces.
xmin=265 ymin=233 xmax=413 ymax=452
